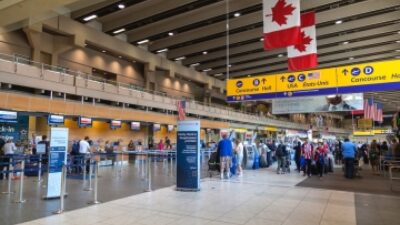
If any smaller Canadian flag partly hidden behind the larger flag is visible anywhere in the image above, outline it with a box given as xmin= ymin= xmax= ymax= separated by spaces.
xmin=287 ymin=12 xmax=318 ymax=70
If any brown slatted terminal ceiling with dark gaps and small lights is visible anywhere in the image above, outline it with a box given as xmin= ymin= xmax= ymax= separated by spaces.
xmin=71 ymin=0 xmax=400 ymax=111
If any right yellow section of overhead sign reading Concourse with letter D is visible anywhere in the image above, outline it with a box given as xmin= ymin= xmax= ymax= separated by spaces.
xmin=337 ymin=60 xmax=400 ymax=87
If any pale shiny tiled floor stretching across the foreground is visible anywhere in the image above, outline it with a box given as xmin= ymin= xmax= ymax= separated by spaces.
xmin=11 ymin=162 xmax=400 ymax=225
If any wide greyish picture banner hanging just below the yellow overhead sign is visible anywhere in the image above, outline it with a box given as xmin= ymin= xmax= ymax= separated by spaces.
xmin=272 ymin=93 xmax=364 ymax=114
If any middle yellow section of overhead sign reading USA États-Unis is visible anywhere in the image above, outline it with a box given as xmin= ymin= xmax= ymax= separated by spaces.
xmin=276 ymin=69 xmax=336 ymax=92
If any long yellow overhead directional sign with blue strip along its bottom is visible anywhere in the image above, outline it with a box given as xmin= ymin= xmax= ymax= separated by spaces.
xmin=227 ymin=60 xmax=400 ymax=102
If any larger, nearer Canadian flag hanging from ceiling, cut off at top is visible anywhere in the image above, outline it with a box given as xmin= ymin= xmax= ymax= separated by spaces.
xmin=263 ymin=0 xmax=301 ymax=50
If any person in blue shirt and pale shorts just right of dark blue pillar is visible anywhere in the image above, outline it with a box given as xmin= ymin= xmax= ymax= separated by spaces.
xmin=218 ymin=133 xmax=232 ymax=179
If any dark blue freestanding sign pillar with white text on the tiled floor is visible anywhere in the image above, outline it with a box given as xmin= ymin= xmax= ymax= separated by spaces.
xmin=176 ymin=121 xmax=200 ymax=191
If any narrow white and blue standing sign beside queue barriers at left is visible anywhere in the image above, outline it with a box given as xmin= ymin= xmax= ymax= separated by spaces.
xmin=44 ymin=127 xmax=68 ymax=199
